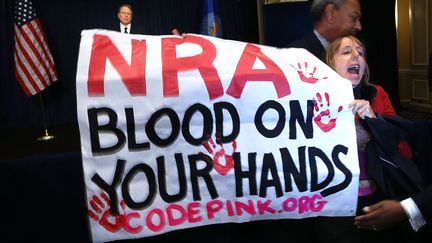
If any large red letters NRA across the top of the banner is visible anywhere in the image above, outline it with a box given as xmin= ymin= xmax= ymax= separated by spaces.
xmin=87 ymin=35 xmax=291 ymax=100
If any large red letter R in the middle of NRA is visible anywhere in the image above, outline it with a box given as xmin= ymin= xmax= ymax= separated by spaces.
xmin=162 ymin=35 xmax=223 ymax=99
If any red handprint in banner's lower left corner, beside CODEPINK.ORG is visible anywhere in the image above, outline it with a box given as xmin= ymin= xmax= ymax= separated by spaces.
xmin=88 ymin=192 xmax=126 ymax=233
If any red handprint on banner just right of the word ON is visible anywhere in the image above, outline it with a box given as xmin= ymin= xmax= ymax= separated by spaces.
xmin=314 ymin=93 xmax=342 ymax=132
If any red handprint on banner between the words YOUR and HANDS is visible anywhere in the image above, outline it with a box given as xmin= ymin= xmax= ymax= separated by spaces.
xmin=203 ymin=138 xmax=237 ymax=175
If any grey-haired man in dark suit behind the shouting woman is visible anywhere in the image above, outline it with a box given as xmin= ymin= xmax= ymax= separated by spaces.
xmin=288 ymin=0 xmax=361 ymax=61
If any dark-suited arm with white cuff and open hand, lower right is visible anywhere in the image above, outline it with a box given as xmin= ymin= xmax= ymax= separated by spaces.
xmin=354 ymin=117 xmax=432 ymax=243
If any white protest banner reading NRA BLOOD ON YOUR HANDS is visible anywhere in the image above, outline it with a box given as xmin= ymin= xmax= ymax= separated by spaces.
xmin=76 ymin=30 xmax=359 ymax=241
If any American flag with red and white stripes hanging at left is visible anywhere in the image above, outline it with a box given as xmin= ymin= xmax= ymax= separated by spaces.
xmin=14 ymin=0 xmax=58 ymax=96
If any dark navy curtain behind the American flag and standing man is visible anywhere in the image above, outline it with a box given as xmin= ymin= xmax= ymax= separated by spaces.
xmin=0 ymin=0 xmax=258 ymax=131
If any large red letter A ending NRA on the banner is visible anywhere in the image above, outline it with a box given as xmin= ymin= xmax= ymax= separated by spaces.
xmin=226 ymin=44 xmax=291 ymax=98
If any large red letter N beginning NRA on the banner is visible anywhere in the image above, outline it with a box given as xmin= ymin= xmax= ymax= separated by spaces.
xmin=87 ymin=35 xmax=146 ymax=96
